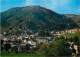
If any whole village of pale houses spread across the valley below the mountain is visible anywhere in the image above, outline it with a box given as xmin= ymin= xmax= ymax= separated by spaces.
xmin=0 ymin=29 xmax=80 ymax=56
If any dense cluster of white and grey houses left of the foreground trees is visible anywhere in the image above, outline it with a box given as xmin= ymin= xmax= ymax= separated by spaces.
xmin=0 ymin=31 xmax=50 ymax=52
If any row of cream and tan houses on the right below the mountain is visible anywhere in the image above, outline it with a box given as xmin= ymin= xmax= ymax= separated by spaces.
xmin=51 ymin=28 xmax=80 ymax=38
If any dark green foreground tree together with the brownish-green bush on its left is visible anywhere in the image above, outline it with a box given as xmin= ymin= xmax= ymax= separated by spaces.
xmin=37 ymin=38 xmax=72 ymax=57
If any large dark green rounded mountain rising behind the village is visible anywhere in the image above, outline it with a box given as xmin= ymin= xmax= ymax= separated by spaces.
xmin=1 ymin=6 xmax=77 ymax=32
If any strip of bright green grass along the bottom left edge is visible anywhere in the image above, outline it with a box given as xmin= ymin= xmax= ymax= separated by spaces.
xmin=0 ymin=53 xmax=45 ymax=57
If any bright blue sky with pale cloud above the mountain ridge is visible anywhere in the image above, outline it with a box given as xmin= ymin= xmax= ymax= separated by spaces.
xmin=0 ymin=0 xmax=80 ymax=14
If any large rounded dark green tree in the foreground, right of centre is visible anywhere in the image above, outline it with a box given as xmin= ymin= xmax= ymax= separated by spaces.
xmin=45 ymin=39 xmax=71 ymax=57
